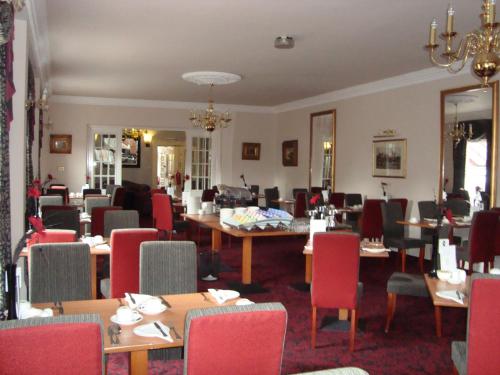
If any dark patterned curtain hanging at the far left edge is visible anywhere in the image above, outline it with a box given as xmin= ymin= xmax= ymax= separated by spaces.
xmin=0 ymin=2 xmax=15 ymax=311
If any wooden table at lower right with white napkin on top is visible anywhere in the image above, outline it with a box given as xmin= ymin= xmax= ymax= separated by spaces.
xmin=424 ymin=274 xmax=470 ymax=337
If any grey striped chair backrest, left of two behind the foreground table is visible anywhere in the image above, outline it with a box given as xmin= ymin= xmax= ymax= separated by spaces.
xmin=29 ymin=242 xmax=92 ymax=303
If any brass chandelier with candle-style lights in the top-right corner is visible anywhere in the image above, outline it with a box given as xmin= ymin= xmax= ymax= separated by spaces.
xmin=425 ymin=0 xmax=500 ymax=86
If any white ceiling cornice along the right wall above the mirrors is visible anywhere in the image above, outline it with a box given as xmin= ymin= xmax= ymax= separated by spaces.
xmin=273 ymin=64 xmax=470 ymax=113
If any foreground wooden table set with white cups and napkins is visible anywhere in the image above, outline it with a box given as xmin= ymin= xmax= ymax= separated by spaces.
xmin=34 ymin=293 xmax=237 ymax=375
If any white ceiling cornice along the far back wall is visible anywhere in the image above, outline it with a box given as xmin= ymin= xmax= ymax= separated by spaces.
xmin=49 ymin=95 xmax=274 ymax=113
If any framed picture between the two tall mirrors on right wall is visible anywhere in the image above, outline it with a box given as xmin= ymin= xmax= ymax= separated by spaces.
xmin=373 ymin=139 xmax=406 ymax=178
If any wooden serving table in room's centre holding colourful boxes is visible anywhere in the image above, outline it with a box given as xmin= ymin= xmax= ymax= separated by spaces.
xmin=182 ymin=214 xmax=309 ymax=285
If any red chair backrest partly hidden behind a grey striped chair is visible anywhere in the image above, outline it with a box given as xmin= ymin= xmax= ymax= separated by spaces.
xmin=106 ymin=228 xmax=158 ymax=298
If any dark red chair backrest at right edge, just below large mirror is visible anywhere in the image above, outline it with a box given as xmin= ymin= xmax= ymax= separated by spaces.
xmin=468 ymin=211 xmax=500 ymax=263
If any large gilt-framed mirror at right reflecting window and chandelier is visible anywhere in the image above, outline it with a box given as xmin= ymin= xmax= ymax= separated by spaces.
xmin=439 ymin=81 xmax=498 ymax=209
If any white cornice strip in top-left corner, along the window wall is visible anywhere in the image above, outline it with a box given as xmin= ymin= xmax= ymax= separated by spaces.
xmin=26 ymin=0 xmax=50 ymax=92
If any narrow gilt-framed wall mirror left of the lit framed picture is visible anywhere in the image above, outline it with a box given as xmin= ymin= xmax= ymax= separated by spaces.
xmin=309 ymin=109 xmax=336 ymax=191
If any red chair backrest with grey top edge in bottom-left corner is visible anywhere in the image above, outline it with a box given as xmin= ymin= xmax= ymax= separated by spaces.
xmin=0 ymin=314 xmax=104 ymax=375
